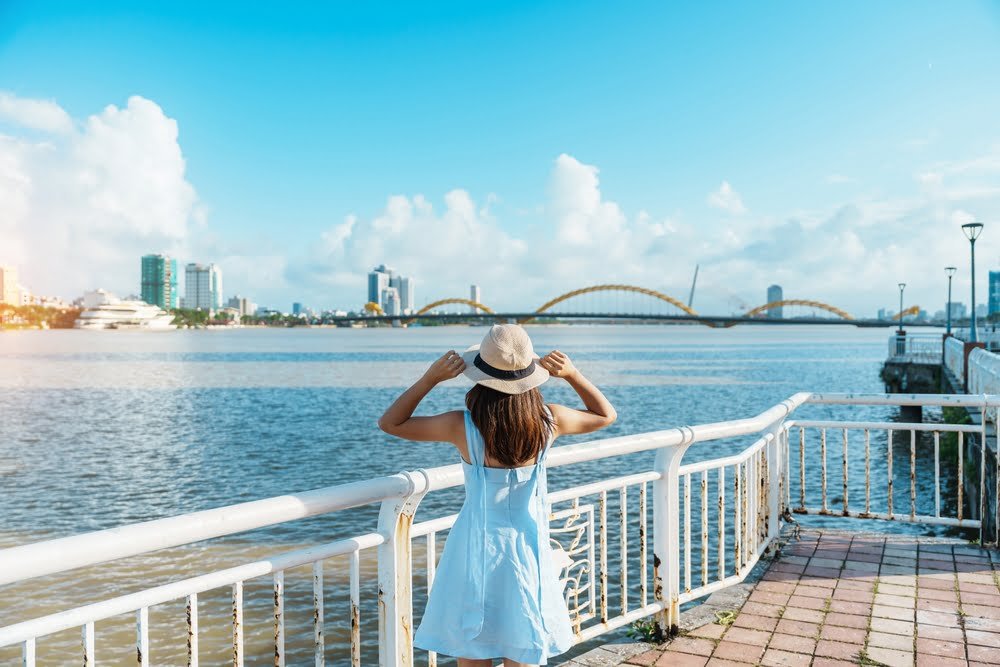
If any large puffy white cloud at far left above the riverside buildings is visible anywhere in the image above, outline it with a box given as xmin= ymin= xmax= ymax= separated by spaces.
xmin=0 ymin=95 xmax=203 ymax=298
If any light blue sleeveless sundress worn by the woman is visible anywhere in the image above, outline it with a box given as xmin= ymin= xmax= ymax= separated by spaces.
xmin=413 ymin=411 xmax=574 ymax=665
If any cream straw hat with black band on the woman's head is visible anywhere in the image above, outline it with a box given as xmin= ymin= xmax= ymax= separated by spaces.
xmin=462 ymin=324 xmax=549 ymax=394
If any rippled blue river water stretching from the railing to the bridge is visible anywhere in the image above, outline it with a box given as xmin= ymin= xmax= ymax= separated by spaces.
xmin=0 ymin=326 xmax=960 ymax=664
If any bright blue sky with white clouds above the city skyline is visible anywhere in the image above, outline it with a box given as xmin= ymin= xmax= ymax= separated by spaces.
xmin=0 ymin=1 xmax=1000 ymax=313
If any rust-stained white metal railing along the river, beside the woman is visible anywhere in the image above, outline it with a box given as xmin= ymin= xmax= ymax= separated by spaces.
xmin=0 ymin=393 xmax=1000 ymax=666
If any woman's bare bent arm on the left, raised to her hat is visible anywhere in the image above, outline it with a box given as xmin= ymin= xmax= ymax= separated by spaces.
xmin=378 ymin=350 xmax=465 ymax=446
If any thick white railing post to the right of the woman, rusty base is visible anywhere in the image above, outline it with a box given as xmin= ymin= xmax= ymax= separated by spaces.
xmin=653 ymin=434 xmax=694 ymax=635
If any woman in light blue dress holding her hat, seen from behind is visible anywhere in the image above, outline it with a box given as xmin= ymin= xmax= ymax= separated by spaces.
xmin=379 ymin=324 xmax=617 ymax=667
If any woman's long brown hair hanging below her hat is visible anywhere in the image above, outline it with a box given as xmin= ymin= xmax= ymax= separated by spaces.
xmin=465 ymin=384 xmax=553 ymax=468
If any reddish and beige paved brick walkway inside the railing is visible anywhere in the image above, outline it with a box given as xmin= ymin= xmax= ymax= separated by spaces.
xmin=608 ymin=531 xmax=1000 ymax=667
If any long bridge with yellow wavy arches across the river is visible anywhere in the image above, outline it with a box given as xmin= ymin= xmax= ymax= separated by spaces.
xmin=350 ymin=284 xmax=920 ymax=327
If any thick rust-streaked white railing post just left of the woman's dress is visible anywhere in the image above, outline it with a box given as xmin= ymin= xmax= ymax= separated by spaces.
xmin=378 ymin=470 xmax=428 ymax=667
